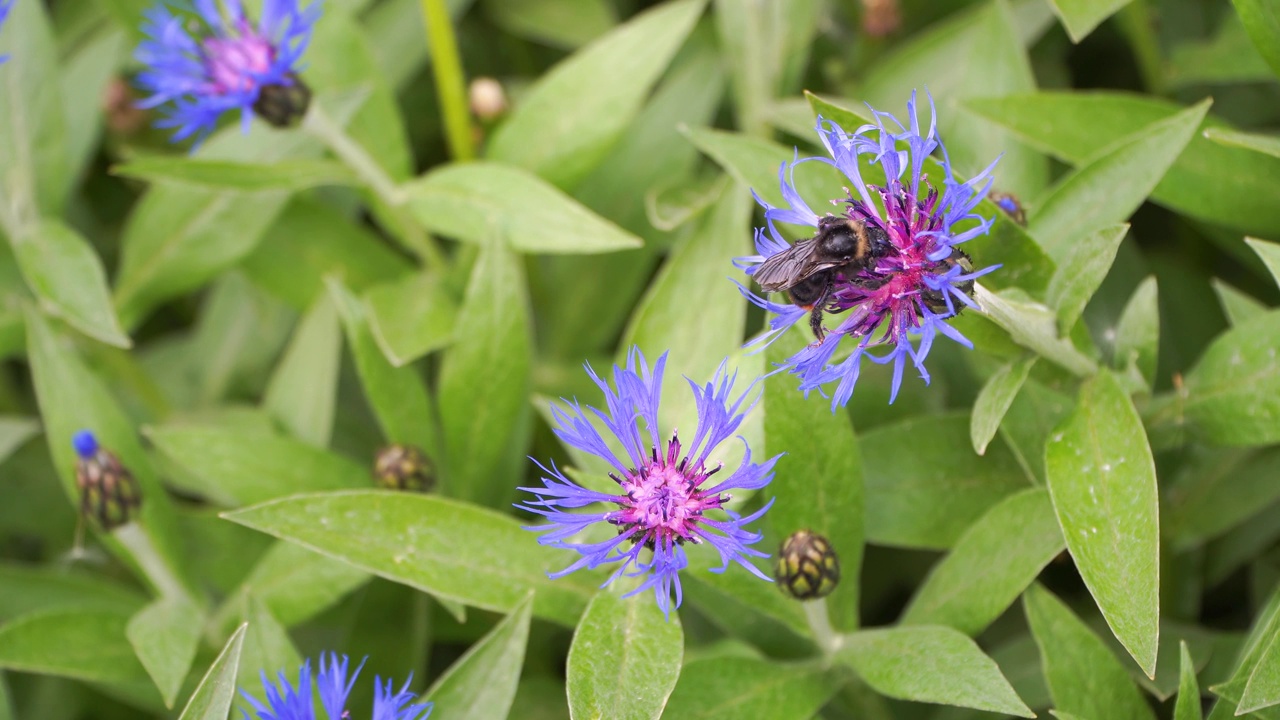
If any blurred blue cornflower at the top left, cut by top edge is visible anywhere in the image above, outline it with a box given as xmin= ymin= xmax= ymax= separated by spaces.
xmin=134 ymin=0 xmax=320 ymax=142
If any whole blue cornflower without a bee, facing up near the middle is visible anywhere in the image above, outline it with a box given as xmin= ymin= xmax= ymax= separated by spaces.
xmin=518 ymin=348 xmax=778 ymax=614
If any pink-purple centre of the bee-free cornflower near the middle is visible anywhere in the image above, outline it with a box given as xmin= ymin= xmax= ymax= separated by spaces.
xmin=607 ymin=436 xmax=730 ymax=548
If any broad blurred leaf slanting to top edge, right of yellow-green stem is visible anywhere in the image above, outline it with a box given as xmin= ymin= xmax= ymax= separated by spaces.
xmin=488 ymin=0 xmax=705 ymax=188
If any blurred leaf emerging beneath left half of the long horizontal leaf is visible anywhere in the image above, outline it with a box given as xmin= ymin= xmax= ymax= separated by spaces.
xmin=214 ymin=542 xmax=369 ymax=632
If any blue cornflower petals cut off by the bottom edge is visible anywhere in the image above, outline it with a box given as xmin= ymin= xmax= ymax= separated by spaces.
xmin=241 ymin=652 xmax=431 ymax=720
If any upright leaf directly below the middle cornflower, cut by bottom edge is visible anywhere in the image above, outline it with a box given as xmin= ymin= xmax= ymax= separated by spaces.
xmin=567 ymin=588 xmax=685 ymax=720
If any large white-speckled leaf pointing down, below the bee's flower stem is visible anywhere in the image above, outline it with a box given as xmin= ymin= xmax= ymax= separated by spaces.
xmin=1044 ymin=370 xmax=1160 ymax=676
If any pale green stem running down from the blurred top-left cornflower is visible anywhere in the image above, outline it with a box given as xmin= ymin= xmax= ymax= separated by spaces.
xmin=302 ymin=102 xmax=445 ymax=269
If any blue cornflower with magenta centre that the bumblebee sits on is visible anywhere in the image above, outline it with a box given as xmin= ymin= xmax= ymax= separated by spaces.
xmin=735 ymin=92 xmax=998 ymax=411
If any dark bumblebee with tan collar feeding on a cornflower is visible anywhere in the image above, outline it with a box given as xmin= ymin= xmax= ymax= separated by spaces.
xmin=753 ymin=215 xmax=893 ymax=342
